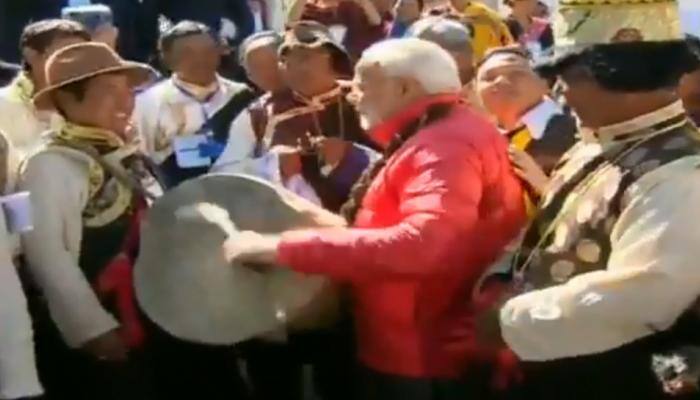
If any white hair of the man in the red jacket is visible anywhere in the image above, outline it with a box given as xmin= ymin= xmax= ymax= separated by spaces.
xmin=357 ymin=38 xmax=462 ymax=94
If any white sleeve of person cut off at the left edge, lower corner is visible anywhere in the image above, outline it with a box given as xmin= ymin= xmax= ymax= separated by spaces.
xmin=0 ymin=212 xmax=42 ymax=399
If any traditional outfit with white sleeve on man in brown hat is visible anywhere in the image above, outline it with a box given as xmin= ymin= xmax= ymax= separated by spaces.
xmin=20 ymin=124 xmax=160 ymax=400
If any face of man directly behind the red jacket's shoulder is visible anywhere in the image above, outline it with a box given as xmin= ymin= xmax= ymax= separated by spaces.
xmin=476 ymin=53 xmax=548 ymax=128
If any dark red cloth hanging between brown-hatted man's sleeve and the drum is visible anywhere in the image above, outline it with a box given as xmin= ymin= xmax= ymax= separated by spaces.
xmin=96 ymin=202 xmax=146 ymax=348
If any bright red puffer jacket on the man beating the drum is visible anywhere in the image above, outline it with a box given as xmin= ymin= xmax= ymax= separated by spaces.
xmin=278 ymin=99 xmax=526 ymax=378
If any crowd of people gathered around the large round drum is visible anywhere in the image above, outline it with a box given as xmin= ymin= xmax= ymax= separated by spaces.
xmin=0 ymin=0 xmax=700 ymax=400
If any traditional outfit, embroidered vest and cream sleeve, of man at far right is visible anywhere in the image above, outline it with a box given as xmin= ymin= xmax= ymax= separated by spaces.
xmin=501 ymin=102 xmax=700 ymax=399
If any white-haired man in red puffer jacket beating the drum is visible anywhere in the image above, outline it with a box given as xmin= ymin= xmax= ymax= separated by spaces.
xmin=225 ymin=39 xmax=525 ymax=400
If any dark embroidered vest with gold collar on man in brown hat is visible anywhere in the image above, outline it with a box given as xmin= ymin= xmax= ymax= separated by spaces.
xmin=45 ymin=123 xmax=161 ymax=347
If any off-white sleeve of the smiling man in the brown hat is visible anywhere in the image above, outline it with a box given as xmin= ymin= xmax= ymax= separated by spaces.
xmin=21 ymin=153 xmax=118 ymax=347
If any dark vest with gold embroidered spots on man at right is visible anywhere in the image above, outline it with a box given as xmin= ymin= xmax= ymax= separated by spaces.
xmin=514 ymin=114 xmax=700 ymax=290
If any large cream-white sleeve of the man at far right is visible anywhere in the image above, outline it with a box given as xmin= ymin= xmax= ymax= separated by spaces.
xmin=501 ymin=157 xmax=700 ymax=361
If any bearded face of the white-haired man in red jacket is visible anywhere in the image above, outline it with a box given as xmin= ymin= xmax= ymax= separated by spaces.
xmin=349 ymin=65 xmax=426 ymax=129
